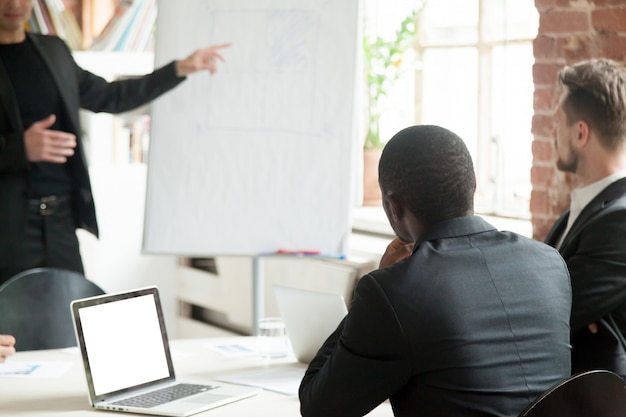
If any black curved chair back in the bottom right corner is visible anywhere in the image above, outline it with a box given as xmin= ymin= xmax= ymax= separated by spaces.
xmin=519 ymin=370 xmax=626 ymax=417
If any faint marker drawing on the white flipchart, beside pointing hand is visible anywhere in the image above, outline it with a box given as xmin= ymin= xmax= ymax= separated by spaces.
xmin=204 ymin=9 xmax=322 ymax=138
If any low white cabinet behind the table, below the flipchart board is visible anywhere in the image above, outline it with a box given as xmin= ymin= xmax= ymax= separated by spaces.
xmin=176 ymin=256 xmax=375 ymax=337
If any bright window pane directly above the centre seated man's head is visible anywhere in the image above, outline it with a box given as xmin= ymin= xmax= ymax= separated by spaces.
xmin=421 ymin=48 xmax=478 ymax=161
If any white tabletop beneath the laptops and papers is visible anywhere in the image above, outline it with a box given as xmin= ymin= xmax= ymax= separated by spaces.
xmin=0 ymin=336 xmax=393 ymax=417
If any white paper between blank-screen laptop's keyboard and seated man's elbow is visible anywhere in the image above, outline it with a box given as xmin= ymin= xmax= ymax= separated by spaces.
xmin=216 ymin=365 xmax=305 ymax=395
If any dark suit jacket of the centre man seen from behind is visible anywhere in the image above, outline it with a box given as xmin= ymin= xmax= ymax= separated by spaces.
xmin=300 ymin=216 xmax=571 ymax=417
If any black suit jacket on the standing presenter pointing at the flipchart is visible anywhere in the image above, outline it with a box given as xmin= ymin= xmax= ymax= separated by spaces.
xmin=0 ymin=33 xmax=184 ymax=269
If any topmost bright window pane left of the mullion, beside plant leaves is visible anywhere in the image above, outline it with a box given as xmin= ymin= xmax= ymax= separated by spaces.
xmin=420 ymin=0 xmax=478 ymax=45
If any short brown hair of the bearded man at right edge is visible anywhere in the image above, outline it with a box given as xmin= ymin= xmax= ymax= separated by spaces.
xmin=559 ymin=59 xmax=626 ymax=150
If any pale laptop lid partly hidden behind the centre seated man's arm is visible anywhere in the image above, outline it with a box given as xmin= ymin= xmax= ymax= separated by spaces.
xmin=273 ymin=285 xmax=348 ymax=363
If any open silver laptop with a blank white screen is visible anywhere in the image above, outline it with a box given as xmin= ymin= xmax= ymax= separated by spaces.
xmin=71 ymin=287 xmax=261 ymax=416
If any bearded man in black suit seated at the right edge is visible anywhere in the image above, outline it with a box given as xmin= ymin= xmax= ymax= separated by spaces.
xmin=546 ymin=59 xmax=626 ymax=377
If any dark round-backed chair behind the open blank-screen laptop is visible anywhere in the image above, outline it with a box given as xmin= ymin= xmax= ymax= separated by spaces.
xmin=0 ymin=268 xmax=104 ymax=351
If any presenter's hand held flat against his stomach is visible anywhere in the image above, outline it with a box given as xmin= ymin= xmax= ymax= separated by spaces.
xmin=24 ymin=114 xmax=76 ymax=164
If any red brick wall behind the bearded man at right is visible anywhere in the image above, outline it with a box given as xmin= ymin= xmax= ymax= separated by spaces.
xmin=528 ymin=0 xmax=626 ymax=240
